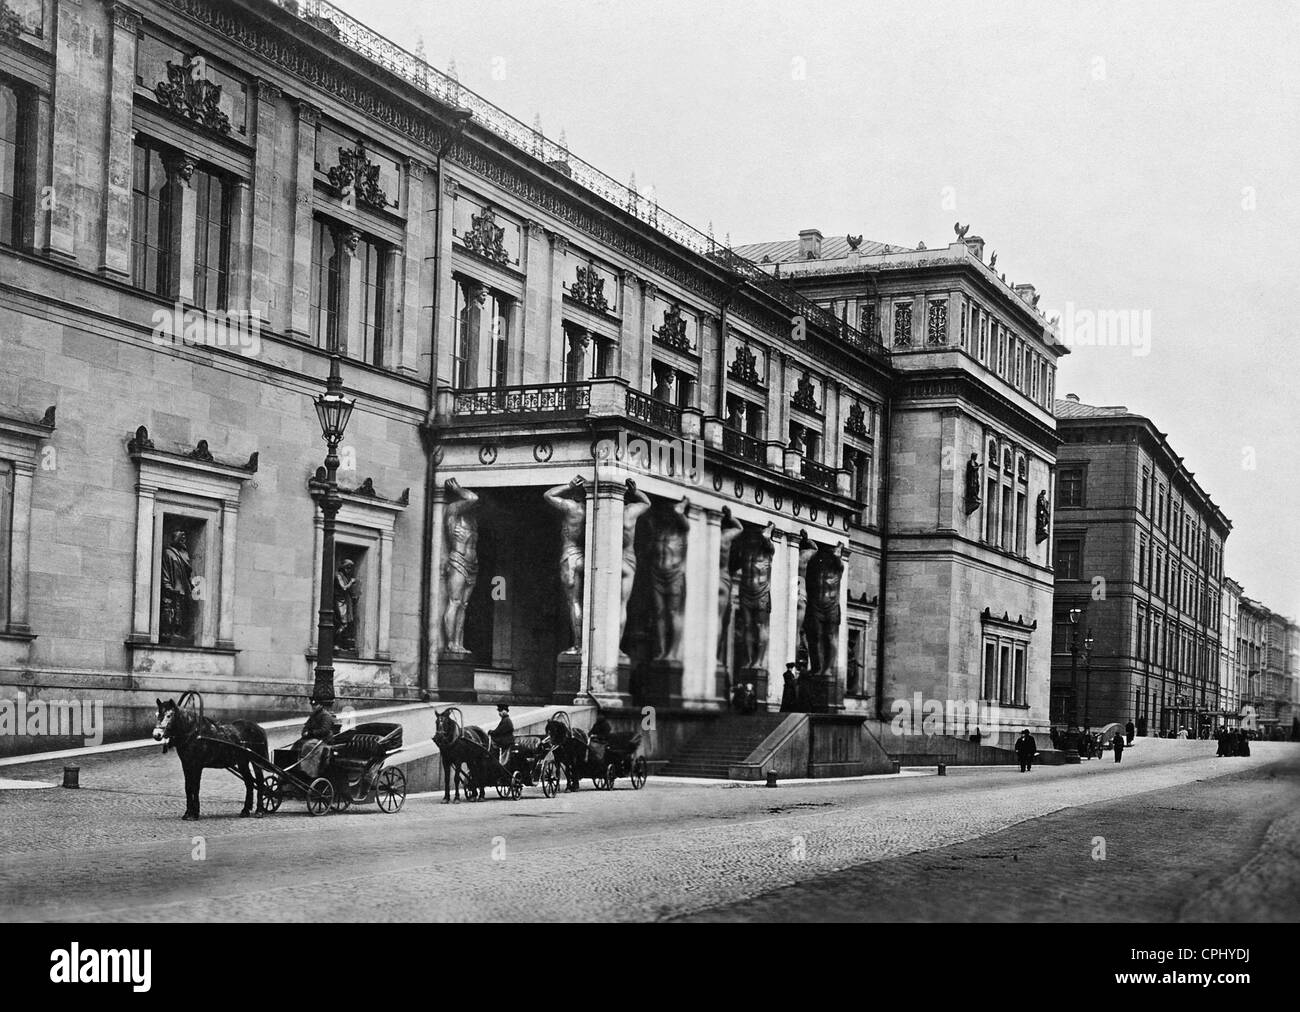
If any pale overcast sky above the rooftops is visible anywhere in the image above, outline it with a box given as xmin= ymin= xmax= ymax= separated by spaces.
xmin=341 ymin=0 xmax=1300 ymax=615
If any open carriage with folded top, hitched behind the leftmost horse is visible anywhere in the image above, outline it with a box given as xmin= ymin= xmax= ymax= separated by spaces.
xmin=264 ymin=723 xmax=407 ymax=816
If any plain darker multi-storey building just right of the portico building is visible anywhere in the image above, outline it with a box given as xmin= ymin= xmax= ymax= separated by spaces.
xmin=1052 ymin=394 xmax=1245 ymax=735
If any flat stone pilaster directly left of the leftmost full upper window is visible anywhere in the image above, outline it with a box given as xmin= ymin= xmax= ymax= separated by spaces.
xmin=96 ymin=0 xmax=138 ymax=281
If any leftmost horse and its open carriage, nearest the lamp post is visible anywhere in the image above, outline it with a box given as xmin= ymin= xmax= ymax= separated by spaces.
xmin=153 ymin=692 xmax=407 ymax=819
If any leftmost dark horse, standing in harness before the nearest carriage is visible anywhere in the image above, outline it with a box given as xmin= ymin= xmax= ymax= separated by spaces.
xmin=153 ymin=692 xmax=270 ymax=822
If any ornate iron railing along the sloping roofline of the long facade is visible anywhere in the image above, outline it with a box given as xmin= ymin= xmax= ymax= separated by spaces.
xmin=270 ymin=0 xmax=888 ymax=358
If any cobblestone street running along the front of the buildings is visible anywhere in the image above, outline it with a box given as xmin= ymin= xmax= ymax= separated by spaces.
xmin=0 ymin=741 xmax=1300 ymax=921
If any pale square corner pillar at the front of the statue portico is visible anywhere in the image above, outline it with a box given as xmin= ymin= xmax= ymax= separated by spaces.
xmin=586 ymin=476 xmax=627 ymax=697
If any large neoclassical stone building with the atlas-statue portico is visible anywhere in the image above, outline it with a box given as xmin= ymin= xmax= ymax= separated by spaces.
xmin=0 ymin=0 xmax=1063 ymax=749
